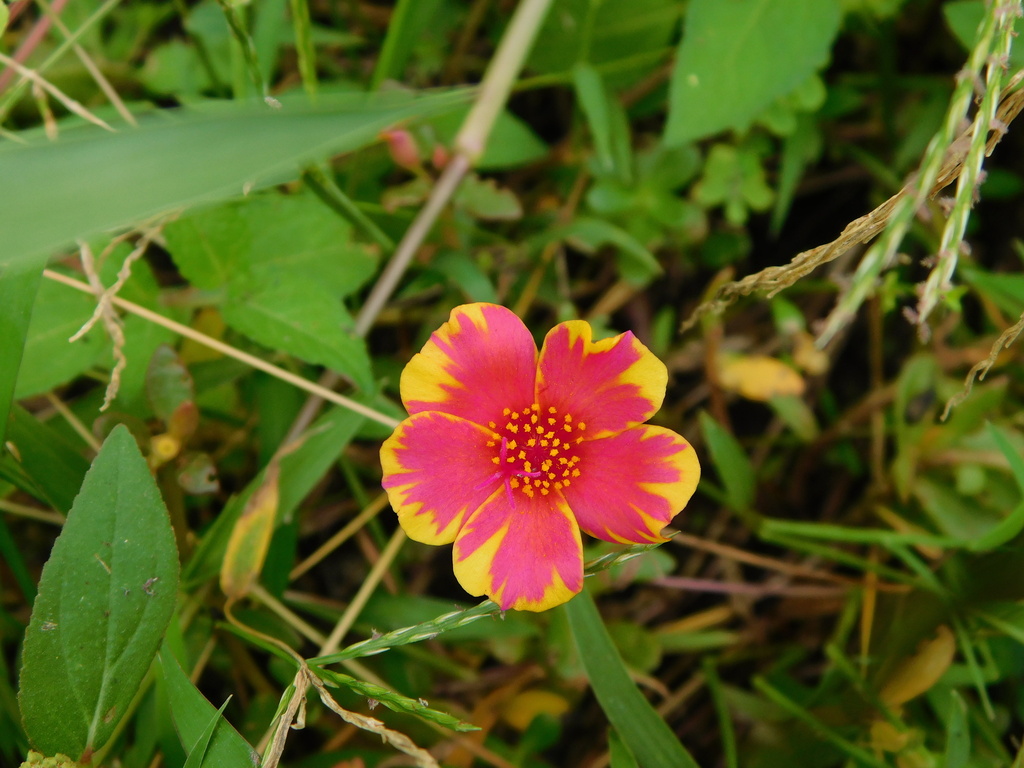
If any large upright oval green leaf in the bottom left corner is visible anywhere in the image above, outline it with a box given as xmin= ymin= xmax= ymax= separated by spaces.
xmin=19 ymin=426 xmax=178 ymax=759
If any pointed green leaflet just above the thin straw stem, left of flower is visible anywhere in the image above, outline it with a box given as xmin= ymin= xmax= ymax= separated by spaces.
xmin=223 ymin=276 xmax=374 ymax=391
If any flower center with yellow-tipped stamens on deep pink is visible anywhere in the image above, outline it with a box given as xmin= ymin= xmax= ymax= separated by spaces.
xmin=481 ymin=402 xmax=587 ymax=507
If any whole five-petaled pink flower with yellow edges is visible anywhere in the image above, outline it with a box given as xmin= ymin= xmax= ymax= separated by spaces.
xmin=381 ymin=304 xmax=700 ymax=610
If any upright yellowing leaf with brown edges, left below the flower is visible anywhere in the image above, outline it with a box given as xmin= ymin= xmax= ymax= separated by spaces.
xmin=220 ymin=461 xmax=281 ymax=601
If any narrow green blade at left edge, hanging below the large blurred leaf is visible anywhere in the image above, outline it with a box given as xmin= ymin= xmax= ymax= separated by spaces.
xmin=0 ymin=264 xmax=42 ymax=445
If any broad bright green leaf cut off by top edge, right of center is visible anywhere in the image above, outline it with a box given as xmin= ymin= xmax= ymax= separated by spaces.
xmin=665 ymin=0 xmax=842 ymax=144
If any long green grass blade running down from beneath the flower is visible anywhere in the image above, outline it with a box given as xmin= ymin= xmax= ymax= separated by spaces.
xmin=563 ymin=590 xmax=697 ymax=768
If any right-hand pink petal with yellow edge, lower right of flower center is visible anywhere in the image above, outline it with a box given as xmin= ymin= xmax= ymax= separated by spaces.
xmin=561 ymin=426 xmax=700 ymax=544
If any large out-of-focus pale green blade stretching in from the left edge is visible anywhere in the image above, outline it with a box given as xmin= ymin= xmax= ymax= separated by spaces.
xmin=0 ymin=93 xmax=462 ymax=272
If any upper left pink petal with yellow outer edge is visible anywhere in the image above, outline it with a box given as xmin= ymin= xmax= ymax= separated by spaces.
xmin=400 ymin=304 xmax=537 ymax=424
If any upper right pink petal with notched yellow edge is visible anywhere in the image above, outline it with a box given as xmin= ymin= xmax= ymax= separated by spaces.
xmin=537 ymin=321 xmax=669 ymax=440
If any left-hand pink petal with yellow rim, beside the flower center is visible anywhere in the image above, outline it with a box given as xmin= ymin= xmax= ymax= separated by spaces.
xmin=381 ymin=412 xmax=498 ymax=544
